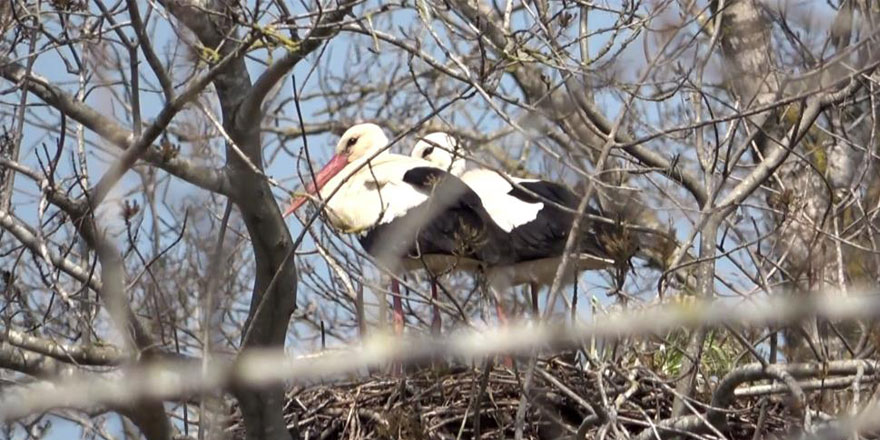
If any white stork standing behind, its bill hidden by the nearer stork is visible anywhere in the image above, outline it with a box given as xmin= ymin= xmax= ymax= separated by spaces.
xmin=411 ymin=132 xmax=614 ymax=315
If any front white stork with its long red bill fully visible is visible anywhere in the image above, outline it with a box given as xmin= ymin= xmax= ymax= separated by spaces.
xmin=284 ymin=124 xmax=514 ymax=333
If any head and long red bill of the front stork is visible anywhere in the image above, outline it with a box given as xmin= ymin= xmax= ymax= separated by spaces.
xmin=284 ymin=124 xmax=388 ymax=217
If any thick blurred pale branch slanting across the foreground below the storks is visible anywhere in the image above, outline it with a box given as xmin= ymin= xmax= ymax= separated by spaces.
xmin=0 ymin=295 xmax=880 ymax=421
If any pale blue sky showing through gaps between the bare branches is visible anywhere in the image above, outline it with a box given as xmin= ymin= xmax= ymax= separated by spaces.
xmin=0 ymin=2 xmax=844 ymax=438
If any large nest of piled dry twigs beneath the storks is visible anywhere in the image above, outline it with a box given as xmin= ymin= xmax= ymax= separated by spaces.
xmin=229 ymin=355 xmax=803 ymax=439
